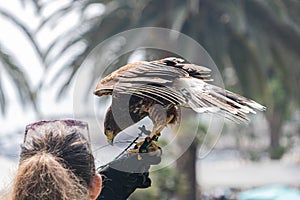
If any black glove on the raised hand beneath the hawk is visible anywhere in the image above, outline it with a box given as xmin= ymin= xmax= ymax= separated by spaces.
xmin=97 ymin=143 xmax=161 ymax=200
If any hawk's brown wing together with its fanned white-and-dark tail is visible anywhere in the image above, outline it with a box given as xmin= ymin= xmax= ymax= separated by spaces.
xmin=95 ymin=58 xmax=264 ymax=122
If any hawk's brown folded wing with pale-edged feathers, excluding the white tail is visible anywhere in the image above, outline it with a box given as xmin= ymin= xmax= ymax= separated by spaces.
xmin=95 ymin=58 xmax=210 ymax=105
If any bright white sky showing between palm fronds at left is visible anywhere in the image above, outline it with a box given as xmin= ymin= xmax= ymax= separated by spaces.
xmin=0 ymin=0 xmax=89 ymax=135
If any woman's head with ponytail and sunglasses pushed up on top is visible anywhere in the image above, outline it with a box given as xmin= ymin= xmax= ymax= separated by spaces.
xmin=12 ymin=120 xmax=102 ymax=200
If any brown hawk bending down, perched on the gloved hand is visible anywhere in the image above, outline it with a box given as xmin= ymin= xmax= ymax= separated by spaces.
xmin=94 ymin=57 xmax=265 ymax=144
